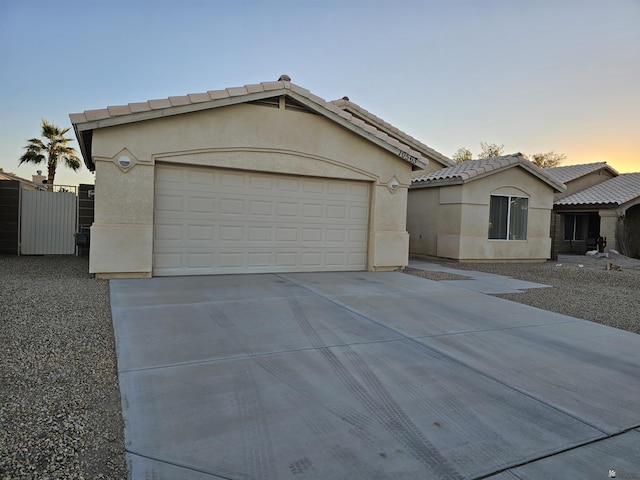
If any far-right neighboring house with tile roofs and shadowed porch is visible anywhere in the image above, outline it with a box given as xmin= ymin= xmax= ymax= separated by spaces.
xmin=545 ymin=162 xmax=640 ymax=257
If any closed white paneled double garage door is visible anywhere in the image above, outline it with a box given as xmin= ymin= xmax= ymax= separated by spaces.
xmin=153 ymin=165 xmax=369 ymax=275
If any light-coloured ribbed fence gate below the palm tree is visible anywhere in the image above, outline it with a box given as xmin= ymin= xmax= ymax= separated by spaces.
xmin=20 ymin=189 xmax=78 ymax=255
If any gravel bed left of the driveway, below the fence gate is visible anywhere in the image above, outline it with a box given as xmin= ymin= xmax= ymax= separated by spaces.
xmin=0 ymin=255 xmax=127 ymax=480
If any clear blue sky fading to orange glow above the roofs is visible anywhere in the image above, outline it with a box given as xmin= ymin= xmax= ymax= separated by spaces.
xmin=0 ymin=0 xmax=640 ymax=185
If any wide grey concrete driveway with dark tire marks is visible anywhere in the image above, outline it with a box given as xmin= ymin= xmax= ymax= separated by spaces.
xmin=110 ymin=272 xmax=640 ymax=480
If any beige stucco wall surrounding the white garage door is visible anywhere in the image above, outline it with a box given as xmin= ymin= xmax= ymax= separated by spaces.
xmin=89 ymin=104 xmax=411 ymax=277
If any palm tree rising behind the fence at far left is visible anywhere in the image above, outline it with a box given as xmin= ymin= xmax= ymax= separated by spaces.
xmin=18 ymin=119 xmax=81 ymax=189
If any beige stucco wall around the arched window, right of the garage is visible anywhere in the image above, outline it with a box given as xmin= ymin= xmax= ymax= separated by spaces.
xmin=407 ymin=167 xmax=553 ymax=261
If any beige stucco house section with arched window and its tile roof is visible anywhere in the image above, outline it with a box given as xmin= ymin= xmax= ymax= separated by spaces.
xmin=407 ymin=153 xmax=565 ymax=262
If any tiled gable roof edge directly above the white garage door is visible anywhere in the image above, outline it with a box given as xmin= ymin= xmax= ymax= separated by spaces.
xmin=69 ymin=79 xmax=428 ymax=174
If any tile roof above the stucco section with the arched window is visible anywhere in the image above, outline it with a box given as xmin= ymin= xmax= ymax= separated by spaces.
xmin=412 ymin=153 xmax=566 ymax=192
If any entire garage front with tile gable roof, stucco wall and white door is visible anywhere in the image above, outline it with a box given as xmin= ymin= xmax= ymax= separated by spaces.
xmin=70 ymin=76 xmax=439 ymax=278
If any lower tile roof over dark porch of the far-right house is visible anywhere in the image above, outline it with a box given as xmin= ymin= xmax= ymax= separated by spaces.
xmin=554 ymin=173 xmax=640 ymax=205
